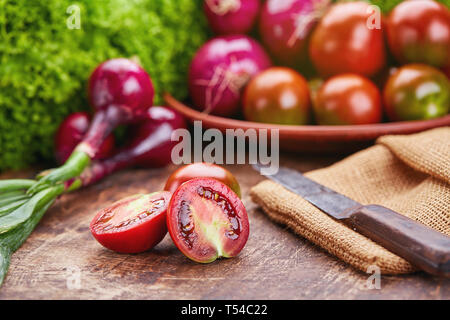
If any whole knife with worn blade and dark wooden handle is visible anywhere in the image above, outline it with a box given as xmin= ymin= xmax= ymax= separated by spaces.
xmin=253 ymin=164 xmax=450 ymax=277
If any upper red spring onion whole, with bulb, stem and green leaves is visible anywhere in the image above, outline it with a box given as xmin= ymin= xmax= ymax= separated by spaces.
xmin=0 ymin=59 xmax=154 ymax=285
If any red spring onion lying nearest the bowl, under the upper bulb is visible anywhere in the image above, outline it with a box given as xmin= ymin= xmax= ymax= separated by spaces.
xmin=81 ymin=106 xmax=187 ymax=186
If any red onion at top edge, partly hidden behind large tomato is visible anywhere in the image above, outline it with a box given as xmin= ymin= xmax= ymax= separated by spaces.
xmin=259 ymin=0 xmax=330 ymax=67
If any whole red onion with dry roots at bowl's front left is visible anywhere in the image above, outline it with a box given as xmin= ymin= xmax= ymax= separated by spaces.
xmin=189 ymin=35 xmax=272 ymax=117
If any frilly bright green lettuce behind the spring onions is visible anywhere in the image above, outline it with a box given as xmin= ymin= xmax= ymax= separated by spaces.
xmin=0 ymin=0 xmax=209 ymax=171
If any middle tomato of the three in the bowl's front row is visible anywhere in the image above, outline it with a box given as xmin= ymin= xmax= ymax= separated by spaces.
xmin=314 ymin=73 xmax=383 ymax=125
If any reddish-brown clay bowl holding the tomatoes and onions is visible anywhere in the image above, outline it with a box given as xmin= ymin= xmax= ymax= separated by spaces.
xmin=164 ymin=93 xmax=450 ymax=154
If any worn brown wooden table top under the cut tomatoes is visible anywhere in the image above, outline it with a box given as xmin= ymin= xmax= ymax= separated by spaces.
xmin=0 ymin=156 xmax=450 ymax=299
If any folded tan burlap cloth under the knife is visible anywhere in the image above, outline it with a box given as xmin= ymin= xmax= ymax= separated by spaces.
xmin=251 ymin=127 xmax=450 ymax=274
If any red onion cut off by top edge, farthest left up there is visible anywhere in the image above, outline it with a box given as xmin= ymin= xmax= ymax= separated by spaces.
xmin=203 ymin=0 xmax=261 ymax=35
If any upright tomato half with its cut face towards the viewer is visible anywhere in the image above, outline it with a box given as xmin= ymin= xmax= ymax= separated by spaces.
xmin=167 ymin=178 xmax=249 ymax=263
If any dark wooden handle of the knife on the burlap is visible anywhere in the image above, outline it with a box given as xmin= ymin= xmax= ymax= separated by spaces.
xmin=343 ymin=205 xmax=450 ymax=277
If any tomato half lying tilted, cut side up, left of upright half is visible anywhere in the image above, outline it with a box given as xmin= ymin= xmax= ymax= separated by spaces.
xmin=90 ymin=191 xmax=171 ymax=253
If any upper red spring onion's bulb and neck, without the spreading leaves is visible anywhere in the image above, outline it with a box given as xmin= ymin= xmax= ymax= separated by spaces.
xmin=28 ymin=58 xmax=154 ymax=190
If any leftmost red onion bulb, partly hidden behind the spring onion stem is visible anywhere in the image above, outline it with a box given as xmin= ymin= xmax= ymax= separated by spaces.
xmin=55 ymin=112 xmax=115 ymax=163
